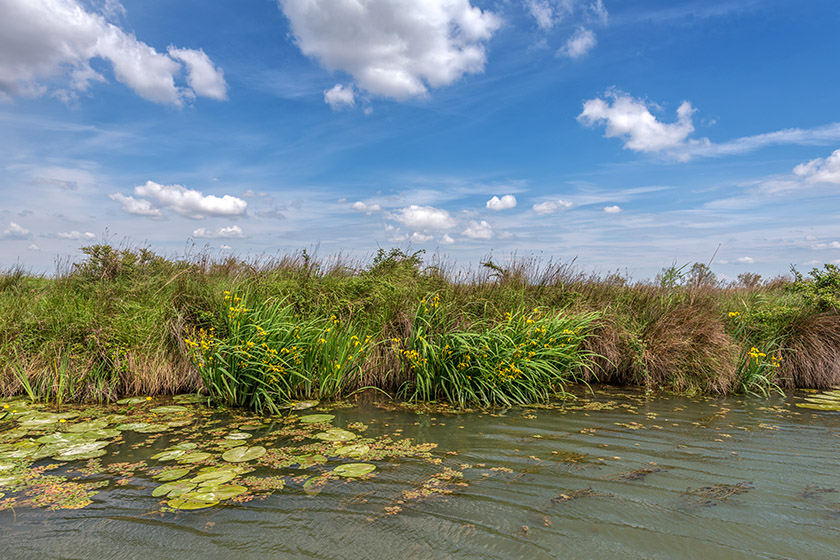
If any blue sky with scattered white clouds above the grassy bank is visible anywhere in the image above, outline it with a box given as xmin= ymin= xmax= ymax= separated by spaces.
xmin=0 ymin=0 xmax=840 ymax=279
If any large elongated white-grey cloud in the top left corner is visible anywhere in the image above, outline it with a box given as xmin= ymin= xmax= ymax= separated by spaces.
xmin=0 ymin=0 xmax=227 ymax=106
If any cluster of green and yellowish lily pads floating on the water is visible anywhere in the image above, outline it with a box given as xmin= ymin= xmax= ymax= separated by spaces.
xmin=0 ymin=396 xmax=446 ymax=511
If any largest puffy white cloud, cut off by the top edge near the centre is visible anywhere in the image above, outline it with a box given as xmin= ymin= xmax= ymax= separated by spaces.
xmin=278 ymin=0 xmax=501 ymax=100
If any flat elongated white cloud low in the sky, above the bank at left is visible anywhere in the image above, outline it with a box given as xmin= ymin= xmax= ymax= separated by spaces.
xmin=134 ymin=181 xmax=248 ymax=219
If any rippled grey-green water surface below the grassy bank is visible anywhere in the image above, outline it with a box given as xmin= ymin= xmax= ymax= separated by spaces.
xmin=0 ymin=390 xmax=840 ymax=560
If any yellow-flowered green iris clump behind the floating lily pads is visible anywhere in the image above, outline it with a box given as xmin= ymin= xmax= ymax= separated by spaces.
xmin=185 ymin=291 xmax=370 ymax=413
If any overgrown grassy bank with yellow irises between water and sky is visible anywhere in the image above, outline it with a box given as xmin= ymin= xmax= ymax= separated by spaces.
xmin=0 ymin=245 xmax=840 ymax=411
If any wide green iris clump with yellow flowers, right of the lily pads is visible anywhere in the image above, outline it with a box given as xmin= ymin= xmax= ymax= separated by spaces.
xmin=398 ymin=294 xmax=597 ymax=405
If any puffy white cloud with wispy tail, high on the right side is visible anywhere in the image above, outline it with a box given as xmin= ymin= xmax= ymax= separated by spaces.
xmin=577 ymin=90 xmax=695 ymax=152
